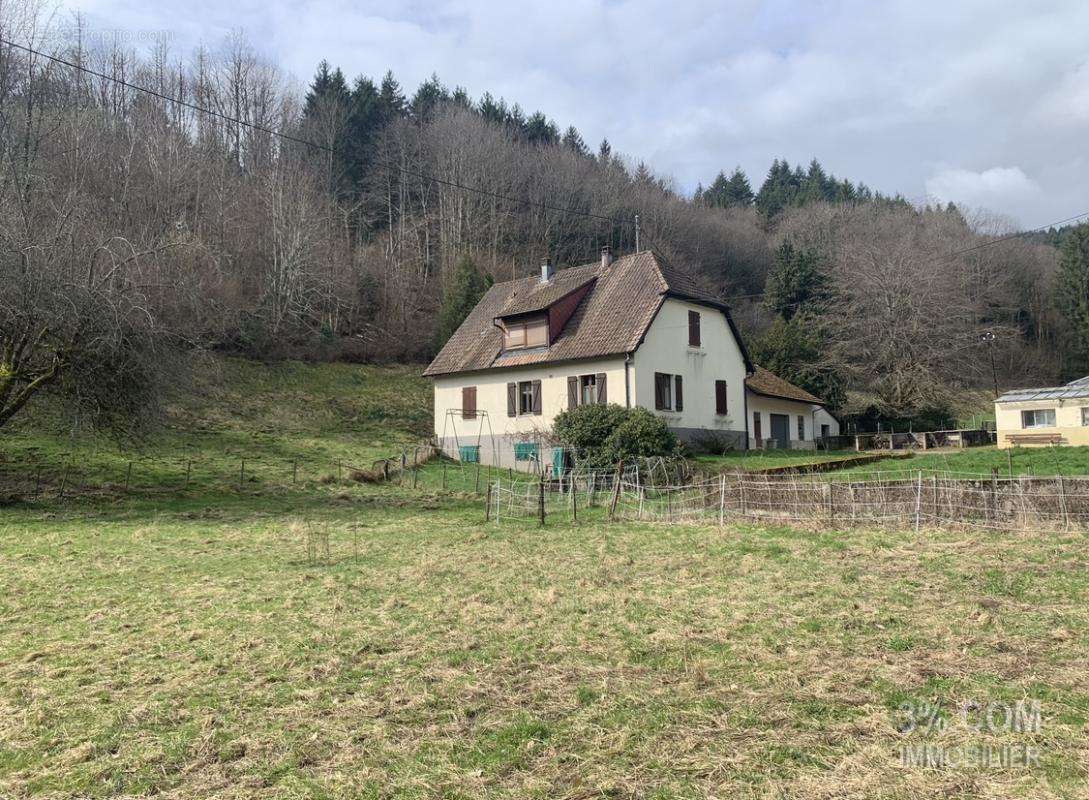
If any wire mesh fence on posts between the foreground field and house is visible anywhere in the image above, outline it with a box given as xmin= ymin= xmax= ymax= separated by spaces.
xmin=486 ymin=469 xmax=1089 ymax=531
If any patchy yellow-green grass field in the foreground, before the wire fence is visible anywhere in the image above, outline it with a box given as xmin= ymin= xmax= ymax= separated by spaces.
xmin=0 ymin=487 xmax=1089 ymax=798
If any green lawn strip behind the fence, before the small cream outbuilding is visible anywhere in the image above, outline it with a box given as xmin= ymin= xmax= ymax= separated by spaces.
xmin=834 ymin=447 xmax=1089 ymax=479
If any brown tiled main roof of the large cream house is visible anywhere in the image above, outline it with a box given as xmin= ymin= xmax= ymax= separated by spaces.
xmin=424 ymin=250 xmax=751 ymax=376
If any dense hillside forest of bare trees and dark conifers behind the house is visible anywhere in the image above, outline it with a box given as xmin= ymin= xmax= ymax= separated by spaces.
xmin=0 ymin=4 xmax=1089 ymax=435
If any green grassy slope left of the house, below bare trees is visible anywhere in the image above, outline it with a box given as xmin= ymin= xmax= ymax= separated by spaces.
xmin=0 ymin=358 xmax=431 ymax=494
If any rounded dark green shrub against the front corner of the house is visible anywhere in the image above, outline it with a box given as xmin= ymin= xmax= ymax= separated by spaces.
xmin=552 ymin=405 xmax=681 ymax=469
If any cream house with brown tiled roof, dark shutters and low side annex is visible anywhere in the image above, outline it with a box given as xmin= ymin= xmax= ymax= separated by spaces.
xmin=424 ymin=248 xmax=839 ymax=469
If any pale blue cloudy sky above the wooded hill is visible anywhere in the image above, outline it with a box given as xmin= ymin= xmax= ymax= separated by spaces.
xmin=65 ymin=0 xmax=1089 ymax=226
